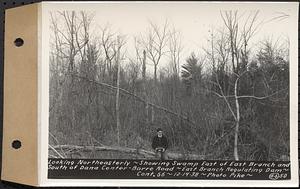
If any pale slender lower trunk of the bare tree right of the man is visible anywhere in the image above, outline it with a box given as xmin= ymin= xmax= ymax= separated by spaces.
xmin=233 ymin=78 xmax=240 ymax=161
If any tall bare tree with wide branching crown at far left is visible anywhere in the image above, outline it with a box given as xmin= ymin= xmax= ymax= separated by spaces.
xmin=51 ymin=11 xmax=96 ymax=137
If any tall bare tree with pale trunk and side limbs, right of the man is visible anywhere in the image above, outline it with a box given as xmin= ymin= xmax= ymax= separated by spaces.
xmin=210 ymin=11 xmax=269 ymax=160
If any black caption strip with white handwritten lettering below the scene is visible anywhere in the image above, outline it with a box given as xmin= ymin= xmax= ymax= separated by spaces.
xmin=48 ymin=159 xmax=290 ymax=180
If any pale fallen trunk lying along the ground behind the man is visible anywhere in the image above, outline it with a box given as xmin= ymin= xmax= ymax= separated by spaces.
xmin=49 ymin=145 xmax=205 ymax=160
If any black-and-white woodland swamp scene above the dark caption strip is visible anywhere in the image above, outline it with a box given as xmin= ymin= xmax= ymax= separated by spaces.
xmin=49 ymin=3 xmax=290 ymax=161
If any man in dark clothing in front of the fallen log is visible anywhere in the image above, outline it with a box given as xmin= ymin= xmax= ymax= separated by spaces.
xmin=152 ymin=128 xmax=168 ymax=160
